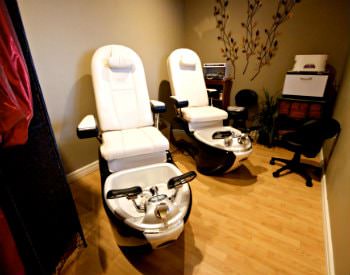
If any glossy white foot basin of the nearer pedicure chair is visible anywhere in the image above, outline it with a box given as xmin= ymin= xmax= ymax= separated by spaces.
xmin=104 ymin=163 xmax=191 ymax=248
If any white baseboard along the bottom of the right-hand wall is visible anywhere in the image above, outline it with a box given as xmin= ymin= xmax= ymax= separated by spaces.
xmin=321 ymin=150 xmax=335 ymax=275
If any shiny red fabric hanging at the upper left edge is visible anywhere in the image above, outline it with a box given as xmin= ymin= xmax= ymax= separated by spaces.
xmin=0 ymin=0 xmax=33 ymax=147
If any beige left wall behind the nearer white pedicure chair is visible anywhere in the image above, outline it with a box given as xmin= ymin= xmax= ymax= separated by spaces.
xmin=18 ymin=0 xmax=184 ymax=173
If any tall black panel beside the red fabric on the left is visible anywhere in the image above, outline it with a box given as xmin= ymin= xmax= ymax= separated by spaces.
xmin=0 ymin=0 xmax=85 ymax=275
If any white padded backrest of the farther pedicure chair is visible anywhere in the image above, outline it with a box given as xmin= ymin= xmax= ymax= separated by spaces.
xmin=167 ymin=49 xmax=209 ymax=107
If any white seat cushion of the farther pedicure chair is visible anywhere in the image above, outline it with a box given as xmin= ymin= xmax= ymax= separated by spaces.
xmin=181 ymin=106 xmax=227 ymax=122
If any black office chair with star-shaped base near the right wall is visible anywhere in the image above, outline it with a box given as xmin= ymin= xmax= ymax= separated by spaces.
xmin=270 ymin=118 xmax=340 ymax=187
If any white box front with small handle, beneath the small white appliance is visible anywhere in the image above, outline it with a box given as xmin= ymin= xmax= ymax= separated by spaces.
xmin=282 ymin=74 xmax=328 ymax=97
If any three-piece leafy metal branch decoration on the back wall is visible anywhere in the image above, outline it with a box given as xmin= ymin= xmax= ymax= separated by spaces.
xmin=214 ymin=0 xmax=300 ymax=81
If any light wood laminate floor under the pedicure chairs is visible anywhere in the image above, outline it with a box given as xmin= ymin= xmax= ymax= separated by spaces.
xmin=61 ymin=145 xmax=326 ymax=275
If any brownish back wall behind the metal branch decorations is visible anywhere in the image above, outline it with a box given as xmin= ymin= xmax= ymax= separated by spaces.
xmin=185 ymin=0 xmax=350 ymax=100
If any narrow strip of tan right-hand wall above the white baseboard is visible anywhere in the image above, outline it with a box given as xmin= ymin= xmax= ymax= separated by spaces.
xmin=327 ymin=51 xmax=350 ymax=275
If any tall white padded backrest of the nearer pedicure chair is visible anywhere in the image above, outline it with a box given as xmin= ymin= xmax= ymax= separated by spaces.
xmin=91 ymin=45 xmax=153 ymax=132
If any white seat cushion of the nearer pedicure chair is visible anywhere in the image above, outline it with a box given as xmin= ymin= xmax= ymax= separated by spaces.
xmin=101 ymin=126 xmax=169 ymax=161
